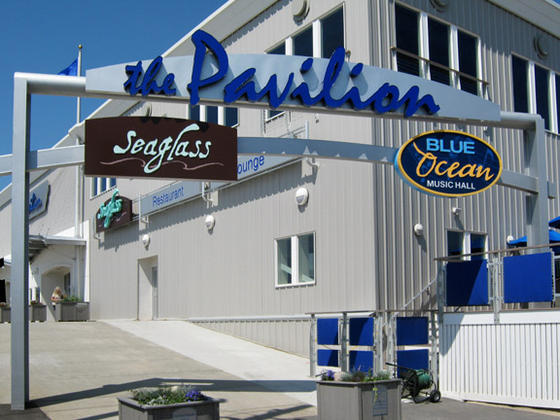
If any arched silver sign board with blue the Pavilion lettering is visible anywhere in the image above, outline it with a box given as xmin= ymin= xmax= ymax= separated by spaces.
xmin=86 ymin=30 xmax=500 ymax=121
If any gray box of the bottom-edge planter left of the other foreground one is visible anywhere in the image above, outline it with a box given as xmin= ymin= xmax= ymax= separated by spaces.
xmin=118 ymin=397 xmax=220 ymax=420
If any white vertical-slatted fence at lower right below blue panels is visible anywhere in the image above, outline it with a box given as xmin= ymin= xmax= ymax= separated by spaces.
xmin=440 ymin=312 xmax=560 ymax=408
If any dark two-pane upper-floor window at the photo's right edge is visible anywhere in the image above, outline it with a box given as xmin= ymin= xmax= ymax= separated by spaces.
xmin=511 ymin=55 xmax=560 ymax=132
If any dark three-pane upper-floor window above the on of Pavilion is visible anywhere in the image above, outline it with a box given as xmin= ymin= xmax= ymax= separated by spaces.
xmin=393 ymin=4 xmax=486 ymax=95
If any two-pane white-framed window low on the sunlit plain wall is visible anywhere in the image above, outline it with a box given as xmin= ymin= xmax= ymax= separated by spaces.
xmin=275 ymin=233 xmax=315 ymax=287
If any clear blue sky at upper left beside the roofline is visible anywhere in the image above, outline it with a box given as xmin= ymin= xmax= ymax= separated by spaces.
xmin=0 ymin=0 xmax=225 ymax=190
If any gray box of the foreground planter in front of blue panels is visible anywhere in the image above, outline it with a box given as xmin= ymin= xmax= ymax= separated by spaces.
xmin=317 ymin=379 xmax=402 ymax=420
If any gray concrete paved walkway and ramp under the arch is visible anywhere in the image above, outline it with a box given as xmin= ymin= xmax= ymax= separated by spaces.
xmin=0 ymin=321 xmax=559 ymax=420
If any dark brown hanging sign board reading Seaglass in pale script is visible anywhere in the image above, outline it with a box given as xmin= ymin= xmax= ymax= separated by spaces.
xmin=85 ymin=117 xmax=237 ymax=181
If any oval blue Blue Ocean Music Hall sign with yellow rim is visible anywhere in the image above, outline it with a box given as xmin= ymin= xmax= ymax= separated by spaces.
xmin=395 ymin=130 xmax=502 ymax=197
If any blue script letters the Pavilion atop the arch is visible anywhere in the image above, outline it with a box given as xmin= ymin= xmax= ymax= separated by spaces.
xmin=129 ymin=30 xmax=440 ymax=117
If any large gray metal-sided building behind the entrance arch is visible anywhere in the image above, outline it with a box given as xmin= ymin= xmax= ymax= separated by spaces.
xmin=0 ymin=0 xmax=560 ymax=355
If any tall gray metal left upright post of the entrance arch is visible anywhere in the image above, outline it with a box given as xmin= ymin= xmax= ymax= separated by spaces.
xmin=10 ymin=75 xmax=31 ymax=410
